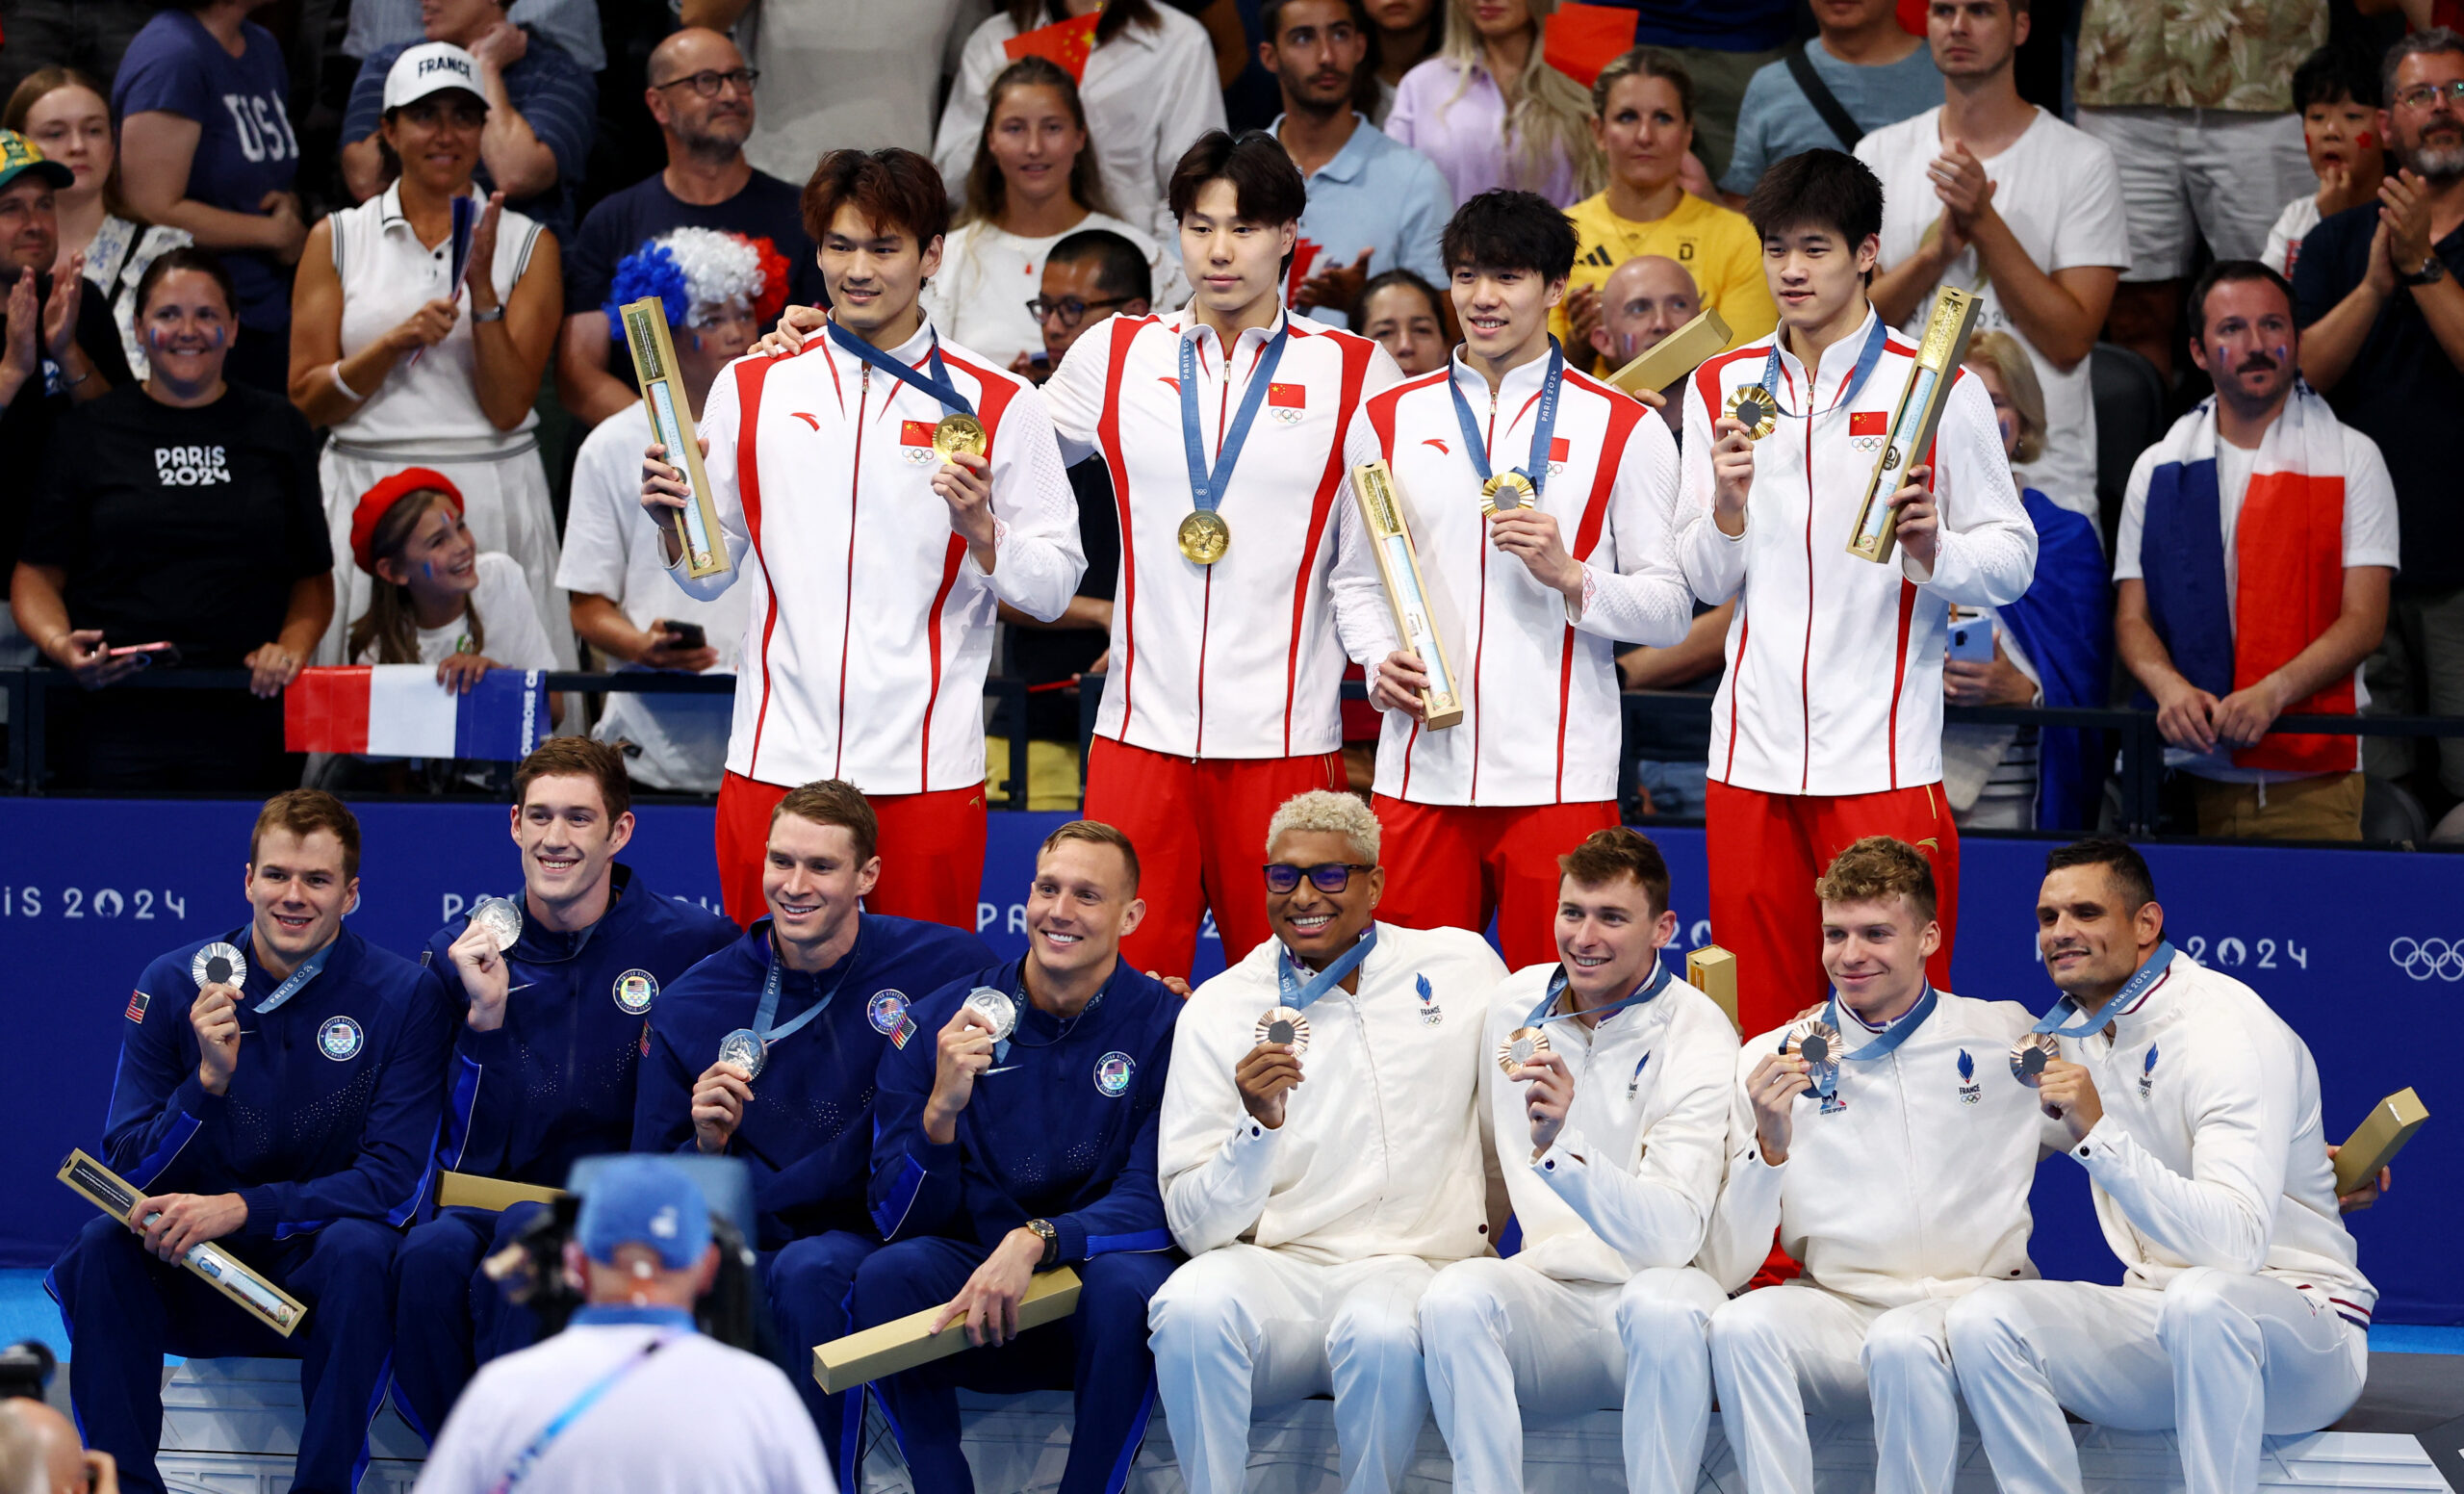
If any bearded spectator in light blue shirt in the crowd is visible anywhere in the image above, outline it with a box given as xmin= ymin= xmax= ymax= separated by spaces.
xmin=1257 ymin=0 xmax=1453 ymax=328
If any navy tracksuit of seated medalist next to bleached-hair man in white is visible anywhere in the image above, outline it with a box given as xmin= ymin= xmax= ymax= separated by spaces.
xmin=853 ymin=959 xmax=1180 ymax=1494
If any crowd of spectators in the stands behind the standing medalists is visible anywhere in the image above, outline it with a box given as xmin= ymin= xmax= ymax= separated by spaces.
xmin=0 ymin=0 xmax=2464 ymax=838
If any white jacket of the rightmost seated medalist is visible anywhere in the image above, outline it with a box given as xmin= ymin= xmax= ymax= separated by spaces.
xmin=2063 ymin=954 xmax=2377 ymax=1328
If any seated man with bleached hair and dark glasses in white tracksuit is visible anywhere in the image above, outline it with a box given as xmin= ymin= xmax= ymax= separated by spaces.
xmin=1148 ymin=791 xmax=1505 ymax=1494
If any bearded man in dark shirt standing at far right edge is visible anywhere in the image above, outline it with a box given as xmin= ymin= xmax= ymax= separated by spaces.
xmin=2294 ymin=27 xmax=2464 ymax=833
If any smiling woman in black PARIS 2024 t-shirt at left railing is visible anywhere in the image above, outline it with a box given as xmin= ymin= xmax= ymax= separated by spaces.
xmin=10 ymin=246 xmax=333 ymax=789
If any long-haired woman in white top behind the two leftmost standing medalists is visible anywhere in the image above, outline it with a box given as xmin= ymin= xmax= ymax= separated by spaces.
xmin=921 ymin=57 xmax=1180 ymax=377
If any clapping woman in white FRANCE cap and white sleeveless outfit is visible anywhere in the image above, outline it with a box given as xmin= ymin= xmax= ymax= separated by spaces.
xmin=291 ymin=42 xmax=574 ymax=668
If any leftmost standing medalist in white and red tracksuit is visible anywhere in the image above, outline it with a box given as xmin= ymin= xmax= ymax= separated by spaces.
xmin=641 ymin=150 xmax=1087 ymax=930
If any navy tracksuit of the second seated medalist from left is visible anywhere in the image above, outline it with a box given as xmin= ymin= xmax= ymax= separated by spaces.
xmin=395 ymin=865 xmax=736 ymax=1442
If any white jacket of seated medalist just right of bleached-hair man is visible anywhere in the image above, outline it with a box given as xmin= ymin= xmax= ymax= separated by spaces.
xmin=1481 ymin=964 xmax=1737 ymax=1282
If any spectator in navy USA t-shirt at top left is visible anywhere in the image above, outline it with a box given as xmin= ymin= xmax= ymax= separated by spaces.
xmin=111 ymin=0 xmax=308 ymax=392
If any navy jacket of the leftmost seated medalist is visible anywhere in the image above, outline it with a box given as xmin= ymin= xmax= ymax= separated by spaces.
xmin=104 ymin=927 xmax=446 ymax=1240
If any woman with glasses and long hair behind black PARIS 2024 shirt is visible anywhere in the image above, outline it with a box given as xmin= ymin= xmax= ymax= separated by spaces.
xmin=0 ymin=66 xmax=192 ymax=379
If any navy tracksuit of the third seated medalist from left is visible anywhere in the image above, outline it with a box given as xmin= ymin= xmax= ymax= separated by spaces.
xmin=633 ymin=913 xmax=993 ymax=1489
